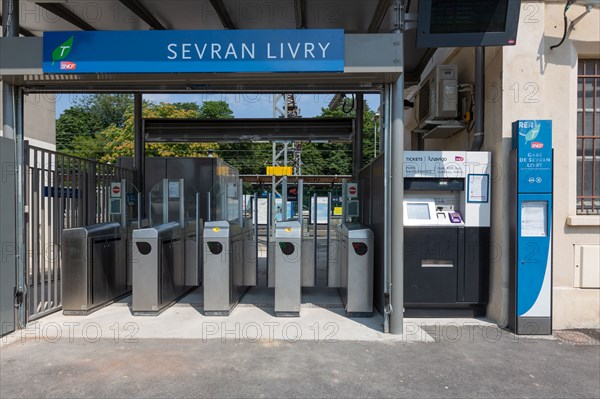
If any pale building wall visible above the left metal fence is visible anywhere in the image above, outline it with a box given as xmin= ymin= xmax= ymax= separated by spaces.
xmin=0 ymin=82 xmax=56 ymax=150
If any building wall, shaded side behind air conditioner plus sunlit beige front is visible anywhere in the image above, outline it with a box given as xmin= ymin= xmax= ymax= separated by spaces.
xmin=406 ymin=1 xmax=600 ymax=329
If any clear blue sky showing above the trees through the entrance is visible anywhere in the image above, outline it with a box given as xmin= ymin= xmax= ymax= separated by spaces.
xmin=56 ymin=93 xmax=379 ymax=118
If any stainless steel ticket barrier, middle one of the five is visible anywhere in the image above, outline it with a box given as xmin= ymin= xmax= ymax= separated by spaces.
xmin=203 ymin=221 xmax=251 ymax=316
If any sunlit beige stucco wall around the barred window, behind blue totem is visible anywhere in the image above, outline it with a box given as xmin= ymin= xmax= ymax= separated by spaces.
xmin=502 ymin=1 xmax=600 ymax=329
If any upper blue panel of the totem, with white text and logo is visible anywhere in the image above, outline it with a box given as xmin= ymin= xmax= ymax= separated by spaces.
xmin=513 ymin=120 xmax=552 ymax=193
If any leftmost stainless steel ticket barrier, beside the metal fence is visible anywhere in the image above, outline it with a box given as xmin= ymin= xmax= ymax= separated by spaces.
xmin=62 ymin=222 xmax=129 ymax=315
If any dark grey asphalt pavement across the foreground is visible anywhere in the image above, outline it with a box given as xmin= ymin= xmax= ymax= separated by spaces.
xmin=0 ymin=326 xmax=600 ymax=398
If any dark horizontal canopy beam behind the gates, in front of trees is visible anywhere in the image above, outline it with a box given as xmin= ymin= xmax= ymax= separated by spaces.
xmin=143 ymin=118 xmax=354 ymax=143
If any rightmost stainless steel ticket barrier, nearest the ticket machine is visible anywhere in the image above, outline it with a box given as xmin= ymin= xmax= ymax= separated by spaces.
xmin=338 ymin=223 xmax=375 ymax=317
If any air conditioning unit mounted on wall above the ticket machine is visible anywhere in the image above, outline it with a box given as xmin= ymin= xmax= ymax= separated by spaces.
xmin=419 ymin=65 xmax=458 ymax=123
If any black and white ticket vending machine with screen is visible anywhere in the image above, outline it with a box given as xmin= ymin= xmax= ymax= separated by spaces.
xmin=403 ymin=151 xmax=491 ymax=317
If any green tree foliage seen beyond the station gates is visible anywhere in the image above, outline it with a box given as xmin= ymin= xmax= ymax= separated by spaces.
xmin=56 ymin=94 xmax=374 ymax=175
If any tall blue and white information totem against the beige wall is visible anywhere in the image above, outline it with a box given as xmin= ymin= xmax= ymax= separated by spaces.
xmin=509 ymin=120 xmax=553 ymax=335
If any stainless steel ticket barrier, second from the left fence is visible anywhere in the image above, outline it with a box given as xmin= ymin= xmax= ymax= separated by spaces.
xmin=132 ymin=222 xmax=190 ymax=316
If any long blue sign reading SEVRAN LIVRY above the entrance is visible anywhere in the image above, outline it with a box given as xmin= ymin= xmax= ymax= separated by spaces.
xmin=43 ymin=29 xmax=344 ymax=73
